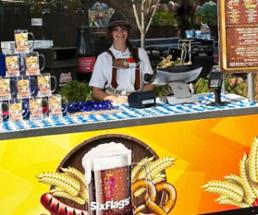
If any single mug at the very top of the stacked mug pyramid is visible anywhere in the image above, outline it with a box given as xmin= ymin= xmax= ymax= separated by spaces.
xmin=14 ymin=29 xmax=35 ymax=53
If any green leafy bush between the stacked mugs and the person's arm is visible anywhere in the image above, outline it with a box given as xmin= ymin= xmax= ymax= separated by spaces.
xmin=60 ymin=80 xmax=91 ymax=102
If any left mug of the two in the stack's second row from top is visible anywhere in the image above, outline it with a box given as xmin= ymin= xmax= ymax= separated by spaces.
xmin=5 ymin=54 xmax=20 ymax=77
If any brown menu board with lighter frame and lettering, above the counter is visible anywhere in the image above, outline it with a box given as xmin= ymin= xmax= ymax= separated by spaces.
xmin=218 ymin=0 xmax=258 ymax=72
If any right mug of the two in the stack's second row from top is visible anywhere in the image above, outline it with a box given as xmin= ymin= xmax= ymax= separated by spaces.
xmin=25 ymin=52 xmax=45 ymax=75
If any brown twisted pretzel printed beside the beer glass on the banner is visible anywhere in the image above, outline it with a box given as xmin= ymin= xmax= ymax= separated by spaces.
xmin=132 ymin=179 xmax=176 ymax=215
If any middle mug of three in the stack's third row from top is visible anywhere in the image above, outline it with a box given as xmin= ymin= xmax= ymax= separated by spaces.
xmin=16 ymin=76 xmax=37 ymax=99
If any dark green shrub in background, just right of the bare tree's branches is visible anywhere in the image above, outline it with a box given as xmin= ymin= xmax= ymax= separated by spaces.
xmin=152 ymin=11 xmax=177 ymax=26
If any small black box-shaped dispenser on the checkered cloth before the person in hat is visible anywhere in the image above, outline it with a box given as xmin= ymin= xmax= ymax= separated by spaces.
xmin=128 ymin=91 xmax=156 ymax=108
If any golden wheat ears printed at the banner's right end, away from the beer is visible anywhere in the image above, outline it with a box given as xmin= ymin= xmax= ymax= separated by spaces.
xmin=203 ymin=137 xmax=258 ymax=208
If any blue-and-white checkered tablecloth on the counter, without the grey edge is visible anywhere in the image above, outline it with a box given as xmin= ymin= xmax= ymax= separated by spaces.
xmin=0 ymin=94 xmax=258 ymax=133
